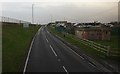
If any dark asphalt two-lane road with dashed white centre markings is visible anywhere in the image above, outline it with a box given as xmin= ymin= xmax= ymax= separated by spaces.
xmin=24 ymin=26 xmax=106 ymax=73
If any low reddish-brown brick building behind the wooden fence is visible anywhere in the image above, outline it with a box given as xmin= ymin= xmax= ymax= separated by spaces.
xmin=75 ymin=27 xmax=111 ymax=40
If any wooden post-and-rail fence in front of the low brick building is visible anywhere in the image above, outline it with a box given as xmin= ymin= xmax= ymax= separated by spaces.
xmin=67 ymin=33 xmax=120 ymax=56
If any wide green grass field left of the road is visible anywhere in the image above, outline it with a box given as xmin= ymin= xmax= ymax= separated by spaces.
xmin=2 ymin=25 xmax=39 ymax=72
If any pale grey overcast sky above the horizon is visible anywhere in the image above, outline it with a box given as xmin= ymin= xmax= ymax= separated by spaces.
xmin=0 ymin=0 xmax=118 ymax=24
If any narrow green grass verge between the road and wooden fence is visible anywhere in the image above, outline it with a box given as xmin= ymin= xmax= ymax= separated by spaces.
xmin=48 ymin=27 xmax=119 ymax=59
